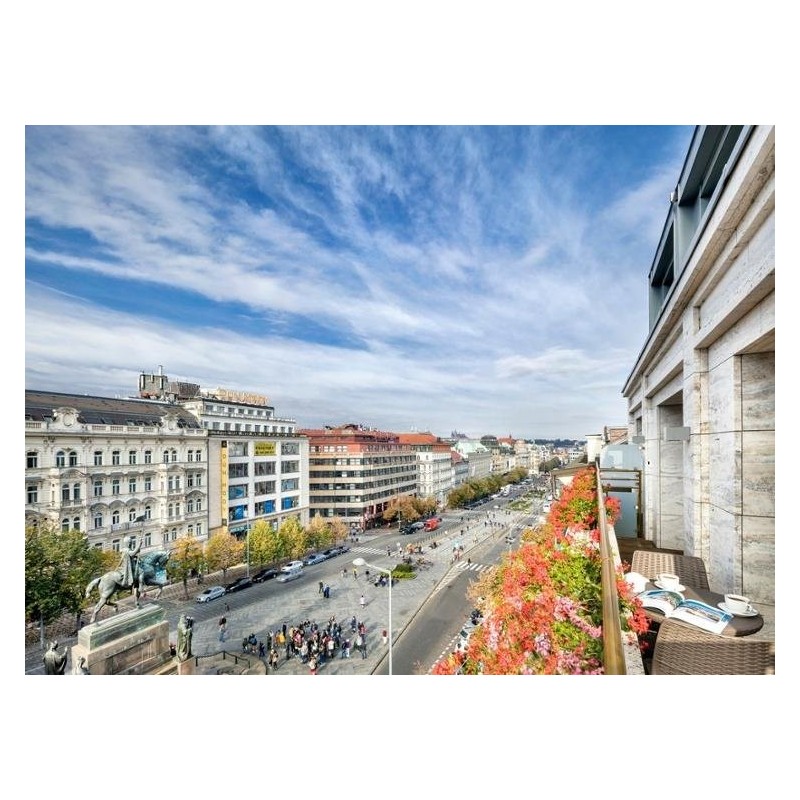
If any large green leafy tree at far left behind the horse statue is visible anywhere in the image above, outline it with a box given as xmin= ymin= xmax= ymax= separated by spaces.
xmin=25 ymin=523 xmax=116 ymax=644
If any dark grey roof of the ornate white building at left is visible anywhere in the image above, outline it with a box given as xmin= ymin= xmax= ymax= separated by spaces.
xmin=25 ymin=389 xmax=200 ymax=428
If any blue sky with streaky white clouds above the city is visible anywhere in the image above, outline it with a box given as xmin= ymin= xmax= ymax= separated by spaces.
xmin=25 ymin=125 xmax=693 ymax=438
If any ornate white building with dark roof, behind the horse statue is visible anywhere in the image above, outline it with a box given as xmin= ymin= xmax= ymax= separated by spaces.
xmin=25 ymin=390 xmax=208 ymax=550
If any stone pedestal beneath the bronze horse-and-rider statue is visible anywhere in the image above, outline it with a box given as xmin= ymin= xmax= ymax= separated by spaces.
xmin=72 ymin=603 xmax=173 ymax=675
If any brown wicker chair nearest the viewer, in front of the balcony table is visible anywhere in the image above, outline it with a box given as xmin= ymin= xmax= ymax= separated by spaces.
xmin=650 ymin=619 xmax=775 ymax=675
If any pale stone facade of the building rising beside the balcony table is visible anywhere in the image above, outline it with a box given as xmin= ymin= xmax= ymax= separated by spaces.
xmin=623 ymin=125 xmax=775 ymax=603
